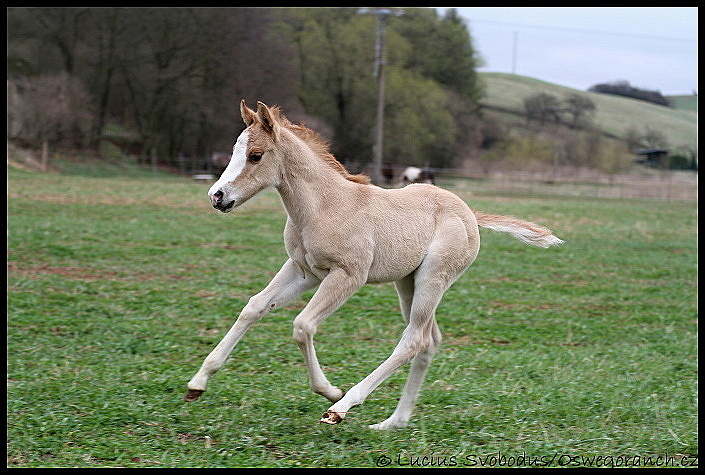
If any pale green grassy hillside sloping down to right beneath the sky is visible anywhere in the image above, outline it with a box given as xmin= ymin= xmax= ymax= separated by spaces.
xmin=480 ymin=73 xmax=697 ymax=147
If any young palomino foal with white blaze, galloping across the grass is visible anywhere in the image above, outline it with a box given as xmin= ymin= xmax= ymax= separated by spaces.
xmin=185 ymin=101 xmax=563 ymax=429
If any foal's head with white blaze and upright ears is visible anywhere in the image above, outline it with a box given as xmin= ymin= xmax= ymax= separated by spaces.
xmin=208 ymin=100 xmax=281 ymax=213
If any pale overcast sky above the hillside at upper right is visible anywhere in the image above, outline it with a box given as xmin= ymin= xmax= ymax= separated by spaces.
xmin=437 ymin=7 xmax=698 ymax=96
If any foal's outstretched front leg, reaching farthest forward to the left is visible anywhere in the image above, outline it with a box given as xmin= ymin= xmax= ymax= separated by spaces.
xmin=184 ymin=259 xmax=320 ymax=401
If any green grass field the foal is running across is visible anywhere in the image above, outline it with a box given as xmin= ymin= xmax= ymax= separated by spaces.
xmin=7 ymin=163 xmax=698 ymax=467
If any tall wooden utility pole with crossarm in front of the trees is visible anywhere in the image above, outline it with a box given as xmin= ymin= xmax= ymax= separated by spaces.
xmin=357 ymin=8 xmax=404 ymax=185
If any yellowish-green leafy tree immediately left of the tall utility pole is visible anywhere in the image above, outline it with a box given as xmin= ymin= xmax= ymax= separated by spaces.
xmin=280 ymin=8 xmax=376 ymax=163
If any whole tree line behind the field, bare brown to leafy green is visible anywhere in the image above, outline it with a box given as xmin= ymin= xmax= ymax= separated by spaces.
xmin=7 ymin=7 xmax=482 ymax=171
